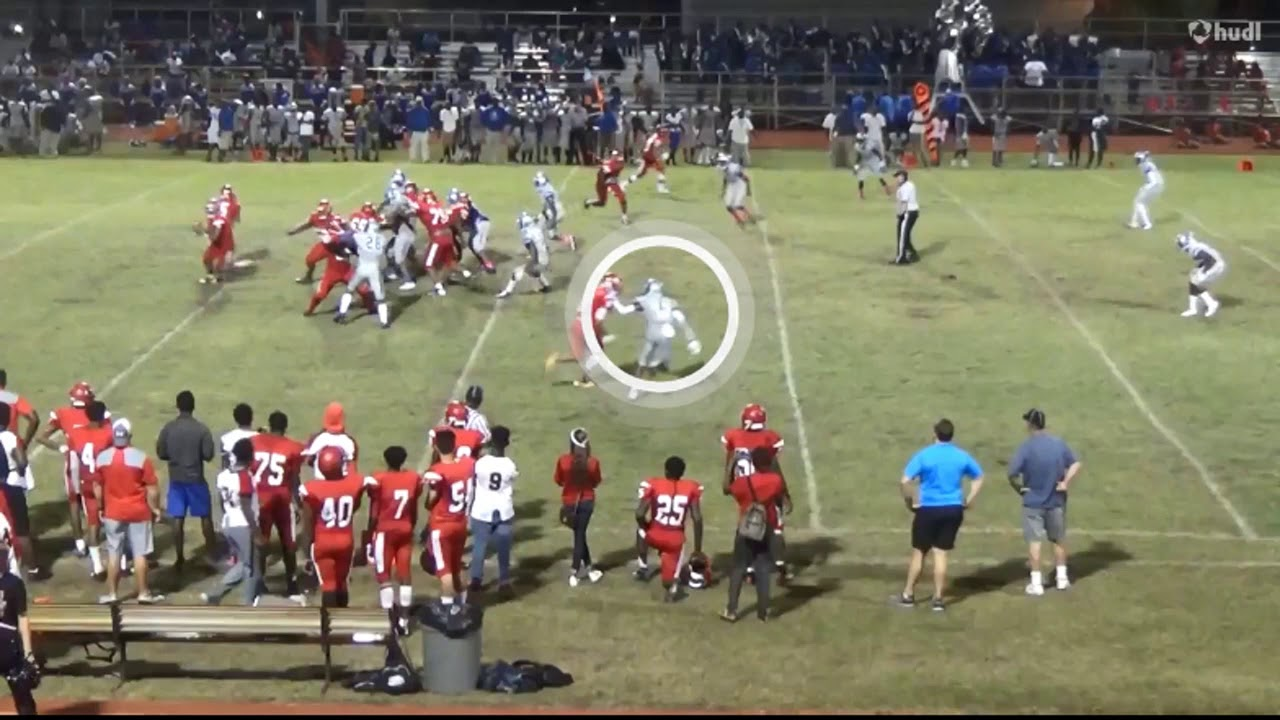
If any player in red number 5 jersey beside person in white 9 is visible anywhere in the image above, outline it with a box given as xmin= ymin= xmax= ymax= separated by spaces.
xmin=422 ymin=430 xmax=476 ymax=611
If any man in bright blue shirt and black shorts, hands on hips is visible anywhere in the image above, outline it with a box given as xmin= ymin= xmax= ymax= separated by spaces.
xmin=897 ymin=418 xmax=982 ymax=612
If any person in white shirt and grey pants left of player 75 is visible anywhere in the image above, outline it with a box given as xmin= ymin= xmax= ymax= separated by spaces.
xmin=200 ymin=440 xmax=259 ymax=606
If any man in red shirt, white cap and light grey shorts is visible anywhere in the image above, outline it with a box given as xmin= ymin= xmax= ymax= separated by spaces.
xmin=93 ymin=418 xmax=165 ymax=605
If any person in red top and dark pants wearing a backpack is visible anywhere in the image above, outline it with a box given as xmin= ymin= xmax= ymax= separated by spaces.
xmin=721 ymin=447 xmax=791 ymax=623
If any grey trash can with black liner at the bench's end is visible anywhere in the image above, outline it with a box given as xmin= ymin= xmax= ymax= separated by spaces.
xmin=417 ymin=602 xmax=484 ymax=694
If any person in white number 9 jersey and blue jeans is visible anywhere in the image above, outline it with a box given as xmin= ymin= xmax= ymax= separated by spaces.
xmin=470 ymin=425 xmax=520 ymax=593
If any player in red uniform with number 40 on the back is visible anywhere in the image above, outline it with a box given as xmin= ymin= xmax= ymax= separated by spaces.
xmin=298 ymin=447 xmax=365 ymax=607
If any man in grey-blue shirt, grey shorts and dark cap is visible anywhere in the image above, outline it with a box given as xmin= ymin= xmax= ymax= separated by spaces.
xmin=1009 ymin=407 xmax=1080 ymax=596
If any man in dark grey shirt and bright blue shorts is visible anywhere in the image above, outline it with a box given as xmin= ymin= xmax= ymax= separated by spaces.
xmin=156 ymin=389 xmax=218 ymax=570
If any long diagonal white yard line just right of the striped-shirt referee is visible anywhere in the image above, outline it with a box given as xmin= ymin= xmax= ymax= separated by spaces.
xmin=934 ymin=183 xmax=1258 ymax=539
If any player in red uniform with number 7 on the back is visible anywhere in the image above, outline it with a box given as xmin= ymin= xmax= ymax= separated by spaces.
xmin=365 ymin=445 xmax=422 ymax=633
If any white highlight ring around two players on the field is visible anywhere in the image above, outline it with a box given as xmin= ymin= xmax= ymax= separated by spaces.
xmin=579 ymin=234 xmax=741 ymax=395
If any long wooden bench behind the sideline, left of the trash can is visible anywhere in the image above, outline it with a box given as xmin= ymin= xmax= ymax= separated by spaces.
xmin=29 ymin=605 xmax=394 ymax=689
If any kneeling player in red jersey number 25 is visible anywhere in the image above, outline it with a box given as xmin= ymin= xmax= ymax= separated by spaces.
xmin=636 ymin=456 xmax=703 ymax=602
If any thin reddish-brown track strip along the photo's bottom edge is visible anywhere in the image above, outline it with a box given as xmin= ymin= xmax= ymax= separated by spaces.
xmin=0 ymin=693 xmax=960 ymax=717
